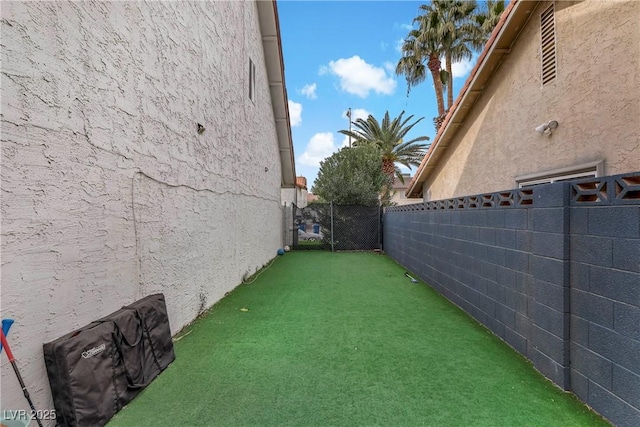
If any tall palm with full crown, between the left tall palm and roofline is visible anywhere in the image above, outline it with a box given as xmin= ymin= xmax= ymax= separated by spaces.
xmin=416 ymin=0 xmax=481 ymax=109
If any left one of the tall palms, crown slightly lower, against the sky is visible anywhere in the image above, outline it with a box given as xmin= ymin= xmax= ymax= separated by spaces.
xmin=396 ymin=30 xmax=445 ymax=116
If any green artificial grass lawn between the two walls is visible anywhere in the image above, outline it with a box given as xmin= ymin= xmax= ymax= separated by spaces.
xmin=109 ymin=251 xmax=608 ymax=427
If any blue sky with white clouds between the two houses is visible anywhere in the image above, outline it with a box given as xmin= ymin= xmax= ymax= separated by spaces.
xmin=278 ymin=0 xmax=474 ymax=189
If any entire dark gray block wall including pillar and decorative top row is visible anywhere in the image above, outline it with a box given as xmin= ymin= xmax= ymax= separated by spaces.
xmin=384 ymin=172 xmax=640 ymax=427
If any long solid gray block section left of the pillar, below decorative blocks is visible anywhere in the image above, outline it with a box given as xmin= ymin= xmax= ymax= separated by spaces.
xmin=384 ymin=202 xmax=546 ymax=366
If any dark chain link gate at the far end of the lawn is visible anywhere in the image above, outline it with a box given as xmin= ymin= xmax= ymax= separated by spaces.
xmin=292 ymin=203 xmax=382 ymax=251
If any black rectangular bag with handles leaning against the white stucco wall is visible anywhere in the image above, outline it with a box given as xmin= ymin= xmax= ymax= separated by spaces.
xmin=43 ymin=294 xmax=175 ymax=426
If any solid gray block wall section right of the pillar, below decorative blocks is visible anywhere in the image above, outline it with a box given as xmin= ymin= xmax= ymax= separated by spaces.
xmin=570 ymin=201 xmax=640 ymax=426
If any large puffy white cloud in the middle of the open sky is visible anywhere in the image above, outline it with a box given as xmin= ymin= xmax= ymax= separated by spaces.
xmin=320 ymin=55 xmax=397 ymax=98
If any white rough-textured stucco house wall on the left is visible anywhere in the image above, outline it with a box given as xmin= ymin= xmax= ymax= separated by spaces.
xmin=1 ymin=2 xmax=283 ymax=422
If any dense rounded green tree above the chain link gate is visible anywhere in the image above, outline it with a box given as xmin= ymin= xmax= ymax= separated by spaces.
xmin=311 ymin=146 xmax=388 ymax=206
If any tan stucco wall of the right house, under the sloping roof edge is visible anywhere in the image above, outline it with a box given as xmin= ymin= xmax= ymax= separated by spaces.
xmin=423 ymin=0 xmax=640 ymax=200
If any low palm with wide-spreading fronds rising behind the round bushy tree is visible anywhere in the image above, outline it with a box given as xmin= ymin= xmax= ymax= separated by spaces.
xmin=339 ymin=111 xmax=429 ymax=185
